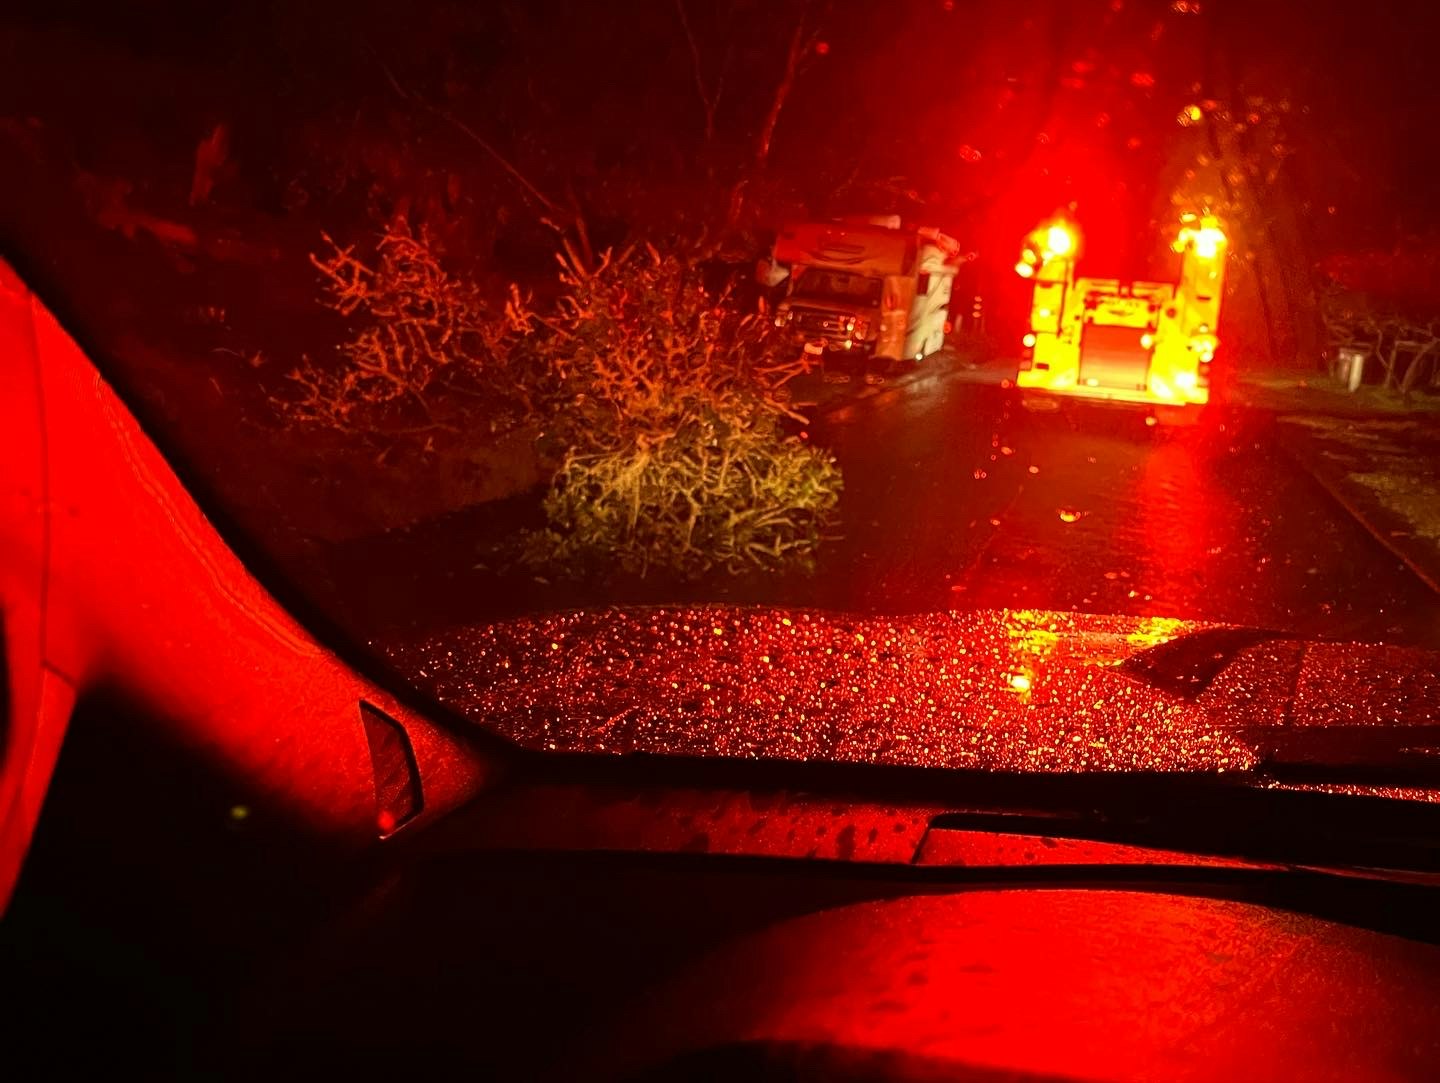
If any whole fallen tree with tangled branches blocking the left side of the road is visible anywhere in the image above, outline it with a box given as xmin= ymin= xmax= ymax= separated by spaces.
xmin=272 ymin=229 xmax=841 ymax=576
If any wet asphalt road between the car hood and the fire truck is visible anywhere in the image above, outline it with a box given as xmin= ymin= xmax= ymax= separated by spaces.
xmin=311 ymin=355 xmax=1440 ymax=647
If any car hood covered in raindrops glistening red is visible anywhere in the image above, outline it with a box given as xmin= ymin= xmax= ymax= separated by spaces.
xmin=383 ymin=606 xmax=1440 ymax=775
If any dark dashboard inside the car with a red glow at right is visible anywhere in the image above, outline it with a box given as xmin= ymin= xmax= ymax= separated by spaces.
xmin=11 ymin=688 xmax=1440 ymax=1082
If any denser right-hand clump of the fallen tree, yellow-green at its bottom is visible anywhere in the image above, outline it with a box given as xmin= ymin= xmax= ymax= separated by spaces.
xmin=536 ymin=241 xmax=841 ymax=575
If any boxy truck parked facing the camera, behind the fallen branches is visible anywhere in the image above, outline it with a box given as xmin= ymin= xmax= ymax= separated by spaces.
xmin=759 ymin=216 xmax=965 ymax=377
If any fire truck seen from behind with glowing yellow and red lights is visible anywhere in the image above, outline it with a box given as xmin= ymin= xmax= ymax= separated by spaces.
xmin=1015 ymin=215 xmax=1227 ymax=406
